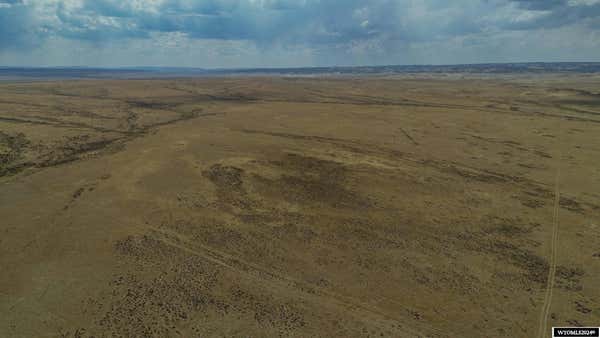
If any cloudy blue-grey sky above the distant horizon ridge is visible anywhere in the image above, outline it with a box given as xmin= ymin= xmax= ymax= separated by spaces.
xmin=0 ymin=0 xmax=600 ymax=68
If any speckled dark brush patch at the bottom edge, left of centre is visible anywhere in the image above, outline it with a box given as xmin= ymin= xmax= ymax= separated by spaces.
xmin=102 ymin=235 xmax=306 ymax=337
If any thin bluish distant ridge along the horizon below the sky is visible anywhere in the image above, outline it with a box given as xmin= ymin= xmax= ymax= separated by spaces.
xmin=0 ymin=62 xmax=600 ymax=79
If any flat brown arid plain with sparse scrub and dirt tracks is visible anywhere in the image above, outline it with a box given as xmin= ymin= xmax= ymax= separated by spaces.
xmin=0 ymin=74 xmax=600 ymax=337
